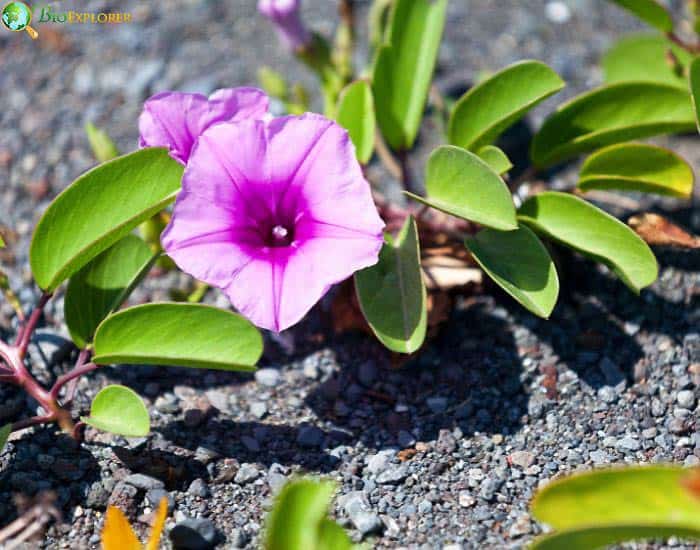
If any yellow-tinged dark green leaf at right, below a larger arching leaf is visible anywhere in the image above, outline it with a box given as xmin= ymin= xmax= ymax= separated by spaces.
xmin=578 ymin=143 xmax=694 ymax=198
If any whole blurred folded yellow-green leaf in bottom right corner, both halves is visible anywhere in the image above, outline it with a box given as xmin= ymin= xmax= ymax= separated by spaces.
xmin=532 ymin=466 xmax=700 ymax=550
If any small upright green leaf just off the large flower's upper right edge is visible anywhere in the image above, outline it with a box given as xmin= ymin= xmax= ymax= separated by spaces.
xmin=337 ymin=80 xmax=375 ymax=164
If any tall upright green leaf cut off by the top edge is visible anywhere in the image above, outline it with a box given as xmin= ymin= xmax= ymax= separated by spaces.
xmin=372 ymin=0 xmax=447 ymax=150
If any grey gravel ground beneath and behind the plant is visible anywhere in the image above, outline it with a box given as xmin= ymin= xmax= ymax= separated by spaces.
xmin=0 ymin=0 xmax=700 ymax=549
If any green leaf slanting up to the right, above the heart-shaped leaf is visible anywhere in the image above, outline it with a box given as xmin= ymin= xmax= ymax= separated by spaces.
xmin=448 ymin=61 xmax=565 ymax=151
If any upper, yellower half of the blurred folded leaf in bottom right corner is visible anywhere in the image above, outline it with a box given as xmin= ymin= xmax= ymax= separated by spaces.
xmin=532 ymin=466 xmax=700 ymax=530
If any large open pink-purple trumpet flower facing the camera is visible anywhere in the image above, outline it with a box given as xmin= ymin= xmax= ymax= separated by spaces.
xmin=162 ymin=114 xmax=384 ymax=332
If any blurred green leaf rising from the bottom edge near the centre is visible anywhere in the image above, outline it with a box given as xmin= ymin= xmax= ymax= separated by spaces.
xmin=265 ymin=479 xmax=353 ymax=550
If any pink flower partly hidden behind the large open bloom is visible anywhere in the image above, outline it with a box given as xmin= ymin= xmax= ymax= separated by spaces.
xmin=139 ymin=88 xmax=268 ymax=164
